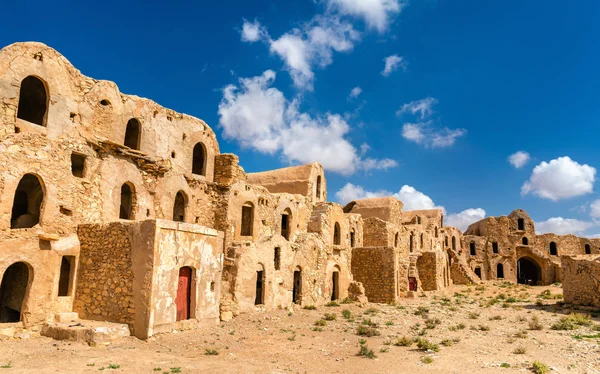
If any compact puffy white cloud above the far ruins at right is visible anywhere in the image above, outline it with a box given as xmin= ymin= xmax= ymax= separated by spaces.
xmin=521 ymin=156 xmax=596 ymax=201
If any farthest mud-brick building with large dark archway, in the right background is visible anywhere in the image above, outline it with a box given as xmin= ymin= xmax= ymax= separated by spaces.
xmin=462 ymin=209 xmax=600 ymax=285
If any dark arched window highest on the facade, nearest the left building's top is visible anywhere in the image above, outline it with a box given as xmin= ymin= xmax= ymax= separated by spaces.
xmin=17 ymin=75 xmax=48 ymax=126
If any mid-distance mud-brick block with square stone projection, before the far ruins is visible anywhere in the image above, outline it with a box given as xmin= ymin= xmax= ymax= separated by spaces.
xmin=344 ymin=197 xmax=460 ymax=303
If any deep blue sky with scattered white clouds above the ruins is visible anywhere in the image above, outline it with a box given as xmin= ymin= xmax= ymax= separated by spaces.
xmin=0 ymin=0 xmax=600 ymax=236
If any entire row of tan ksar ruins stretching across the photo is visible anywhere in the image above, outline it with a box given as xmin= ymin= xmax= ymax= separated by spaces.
xmin=0 ymin=43 xmax=600 ymax=366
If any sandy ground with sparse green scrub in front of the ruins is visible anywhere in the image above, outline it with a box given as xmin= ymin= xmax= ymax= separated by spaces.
xmin=0 ymin=283 xmax=600 ymax=374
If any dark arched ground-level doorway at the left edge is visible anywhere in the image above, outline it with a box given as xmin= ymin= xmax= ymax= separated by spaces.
xmin=0 ymin=262 xmax=30 ymax=323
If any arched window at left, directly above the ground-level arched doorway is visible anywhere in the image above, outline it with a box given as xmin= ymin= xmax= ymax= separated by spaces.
xmin=10 ymin=174 xmax=44 ymax=229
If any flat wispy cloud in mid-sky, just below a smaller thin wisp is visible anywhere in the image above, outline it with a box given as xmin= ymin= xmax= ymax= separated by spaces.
xmin=402 ymin=122 xmax=467 ymax=148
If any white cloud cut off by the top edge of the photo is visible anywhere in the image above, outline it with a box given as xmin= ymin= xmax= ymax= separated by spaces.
xmin=326 ymin=0 xmax=407 ymax=32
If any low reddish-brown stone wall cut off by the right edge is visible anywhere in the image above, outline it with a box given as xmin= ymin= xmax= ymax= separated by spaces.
xmin=562 ymin=256 xmax=600 ymax=307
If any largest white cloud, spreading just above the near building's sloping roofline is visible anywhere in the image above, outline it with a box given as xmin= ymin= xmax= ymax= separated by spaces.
xmin=219 ymin=70 xmax=398 ymax=175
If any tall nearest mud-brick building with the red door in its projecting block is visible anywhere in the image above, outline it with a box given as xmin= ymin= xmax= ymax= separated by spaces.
xmin=0 ymin=43 xmax=362 ymax=338
